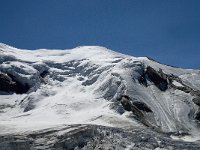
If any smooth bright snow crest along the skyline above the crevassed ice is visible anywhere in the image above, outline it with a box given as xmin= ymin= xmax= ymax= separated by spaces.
xmin=0 ymin=44 xmax=138 ymax=62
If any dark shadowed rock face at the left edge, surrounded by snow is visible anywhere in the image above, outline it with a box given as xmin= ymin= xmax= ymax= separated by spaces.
xmin=0 ymin=73 xmax=30 ymax=94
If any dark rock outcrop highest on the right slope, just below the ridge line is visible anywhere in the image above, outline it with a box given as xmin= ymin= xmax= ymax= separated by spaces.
xmin=146 ymin=66 xmax=168 ymax=91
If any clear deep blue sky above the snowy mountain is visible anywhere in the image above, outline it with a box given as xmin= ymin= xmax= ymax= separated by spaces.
xmin=0 ymin=0 xmax=200 ymax=69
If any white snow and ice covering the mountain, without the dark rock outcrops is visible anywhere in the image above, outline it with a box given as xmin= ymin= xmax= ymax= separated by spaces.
xmin=0 ymin=44 xmax=200 ymax=141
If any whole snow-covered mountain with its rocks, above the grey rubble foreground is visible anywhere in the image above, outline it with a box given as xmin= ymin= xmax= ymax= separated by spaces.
xmin=0 ymin=44 xmax=200 ymax=149
